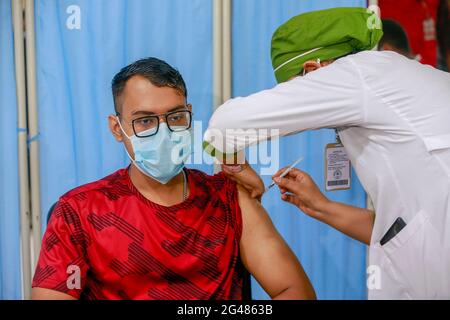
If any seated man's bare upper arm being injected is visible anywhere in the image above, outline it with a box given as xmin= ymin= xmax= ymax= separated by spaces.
xmin=238 ymin=186 xmax=315 ymax=299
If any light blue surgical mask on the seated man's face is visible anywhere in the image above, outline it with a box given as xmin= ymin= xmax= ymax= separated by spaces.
xmin=119 ymin=121 xmax=192 ymax=184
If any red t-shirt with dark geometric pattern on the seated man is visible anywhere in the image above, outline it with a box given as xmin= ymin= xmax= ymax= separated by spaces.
xmin=33 ymin=169 xmax=244 ymax=300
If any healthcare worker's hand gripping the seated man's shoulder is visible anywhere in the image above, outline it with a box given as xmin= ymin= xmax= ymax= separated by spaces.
xmin=222 ymin=163 xmax=265 ymax=200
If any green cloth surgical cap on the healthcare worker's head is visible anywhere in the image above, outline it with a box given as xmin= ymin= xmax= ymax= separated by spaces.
xmin=271 ymin=8 xmax=383 ymax=83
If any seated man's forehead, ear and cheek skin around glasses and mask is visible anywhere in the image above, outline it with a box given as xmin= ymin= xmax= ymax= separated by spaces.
xmin=108 ymin=76 xmax=191 ymax=159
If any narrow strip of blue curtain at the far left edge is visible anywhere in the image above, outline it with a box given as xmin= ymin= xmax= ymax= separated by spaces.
xmin=0 ymin=1 xmax=22 ymax=300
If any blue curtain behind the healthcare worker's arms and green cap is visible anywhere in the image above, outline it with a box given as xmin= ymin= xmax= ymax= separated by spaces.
xmin=233 ymin=0 xmax=366 ymax=299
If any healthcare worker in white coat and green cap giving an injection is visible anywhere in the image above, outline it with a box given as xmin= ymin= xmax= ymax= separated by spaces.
xmin=204 ymin=8 xmax=450 ymax=299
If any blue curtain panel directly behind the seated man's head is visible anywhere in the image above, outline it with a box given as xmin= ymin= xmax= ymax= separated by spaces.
xmin=35 ymin=0 xmax=212 ymax=229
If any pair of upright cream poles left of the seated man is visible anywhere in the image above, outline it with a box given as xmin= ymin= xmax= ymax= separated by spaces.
xmin=12 ymin=0 xmax=41 ymax=299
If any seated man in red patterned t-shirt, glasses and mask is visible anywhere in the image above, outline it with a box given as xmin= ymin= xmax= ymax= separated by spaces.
xmin=32 ymin=58 xmax=315 ymax=300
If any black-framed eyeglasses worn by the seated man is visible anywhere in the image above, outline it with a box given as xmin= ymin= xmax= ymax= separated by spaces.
xmin=117 ymin=110 xmax=192 ymax=138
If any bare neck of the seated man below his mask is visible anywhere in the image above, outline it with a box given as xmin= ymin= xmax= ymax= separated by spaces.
xmin=129 ymin=164 xmax=187 ymax=206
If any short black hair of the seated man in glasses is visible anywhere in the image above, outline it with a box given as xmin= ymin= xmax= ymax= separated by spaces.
xmin=111 ymin=57 xmax=187 ymax=114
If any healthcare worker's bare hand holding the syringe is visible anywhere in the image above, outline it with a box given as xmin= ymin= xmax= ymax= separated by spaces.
xmin=272 ymin=167 xmax=330 ymax=218
